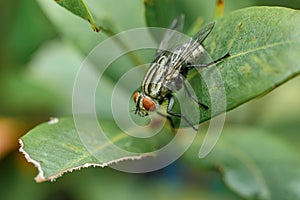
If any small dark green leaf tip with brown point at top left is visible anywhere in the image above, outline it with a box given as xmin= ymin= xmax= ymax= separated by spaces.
xmin=55 ymin=0 xmax=99 ymax=32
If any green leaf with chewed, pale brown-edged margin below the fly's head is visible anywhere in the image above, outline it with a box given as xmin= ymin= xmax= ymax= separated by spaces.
xmin=20 ymin=118 xmax=172 ymax=182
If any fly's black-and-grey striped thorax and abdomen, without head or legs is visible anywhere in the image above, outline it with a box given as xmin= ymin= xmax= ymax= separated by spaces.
xmin=142 ymin=40 xmax=204 ymax=100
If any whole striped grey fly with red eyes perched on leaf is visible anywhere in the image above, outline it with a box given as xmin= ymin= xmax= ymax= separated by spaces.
xmin=133 ymin=15 xmax=230 ymax=130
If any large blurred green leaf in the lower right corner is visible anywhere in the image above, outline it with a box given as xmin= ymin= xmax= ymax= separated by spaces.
xmin=184 ymin=127 xmax=300 ymax=199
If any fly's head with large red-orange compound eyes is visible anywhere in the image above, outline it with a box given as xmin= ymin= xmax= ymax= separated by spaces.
xmin=133 ymin=92 xmax=157 ymax=116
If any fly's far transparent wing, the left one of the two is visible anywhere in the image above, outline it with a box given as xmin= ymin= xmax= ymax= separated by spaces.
xmin=155 ymin=14 xmax=184 ymax=57
